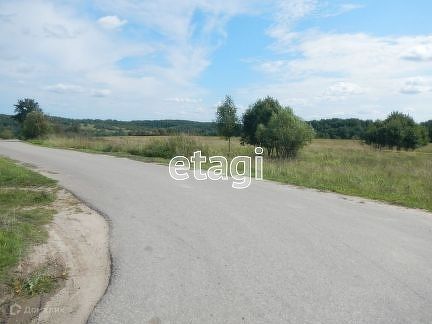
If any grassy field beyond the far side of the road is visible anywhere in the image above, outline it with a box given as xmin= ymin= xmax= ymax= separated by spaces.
xmin=33 ymin=136 xmax=432 ymax=211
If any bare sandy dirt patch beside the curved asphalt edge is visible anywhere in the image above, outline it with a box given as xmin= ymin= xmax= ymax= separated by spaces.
xmin=3 ymin=189 xmax=110 ymax=324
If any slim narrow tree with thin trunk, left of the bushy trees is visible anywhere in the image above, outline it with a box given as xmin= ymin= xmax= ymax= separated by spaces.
xmin=216 ymin=96 xmax=239 ymax=153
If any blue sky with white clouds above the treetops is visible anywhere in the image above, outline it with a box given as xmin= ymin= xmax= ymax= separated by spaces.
xmin=0 ymin=0 xmax=432 ymax=121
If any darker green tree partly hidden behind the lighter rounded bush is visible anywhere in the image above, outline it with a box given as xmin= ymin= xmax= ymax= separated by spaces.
xmin=242 ymin=97 xmax=283 ymax=145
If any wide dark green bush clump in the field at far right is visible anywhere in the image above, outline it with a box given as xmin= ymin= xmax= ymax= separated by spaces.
xmin=364 ymin=112 xmax=429 ymax=150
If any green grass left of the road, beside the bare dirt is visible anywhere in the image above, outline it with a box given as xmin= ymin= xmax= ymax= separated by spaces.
xmin=0 ymin=158 xmax=56 ymax=295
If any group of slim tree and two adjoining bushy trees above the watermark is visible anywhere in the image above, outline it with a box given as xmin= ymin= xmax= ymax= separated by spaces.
xmin=216 ymin=96 xmax=314 ymax=158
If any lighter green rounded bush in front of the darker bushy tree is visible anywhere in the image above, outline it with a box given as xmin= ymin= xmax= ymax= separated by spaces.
xmin=256 ymin=108 xmax=314 ymax=158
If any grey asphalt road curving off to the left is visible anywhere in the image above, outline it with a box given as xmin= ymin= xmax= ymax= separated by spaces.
xmin=0 ymin=141 xmax=432 ymax=324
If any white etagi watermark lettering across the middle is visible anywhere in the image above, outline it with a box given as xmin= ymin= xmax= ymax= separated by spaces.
xmin=169 ymin=146 xmax=263 ymax=189
